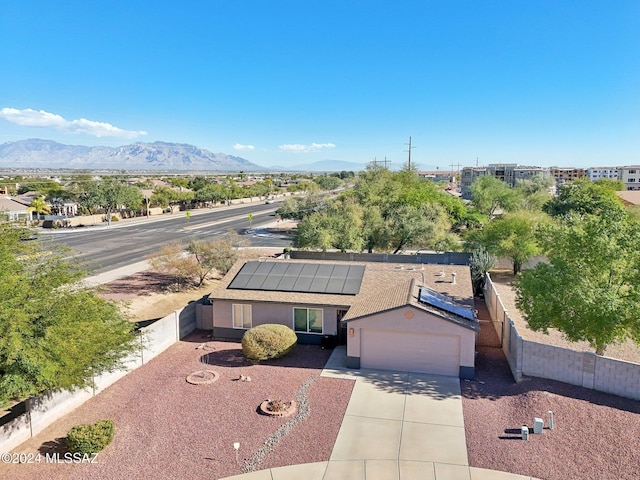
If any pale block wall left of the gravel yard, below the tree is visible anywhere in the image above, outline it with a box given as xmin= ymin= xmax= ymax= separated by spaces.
xmin=0 ymin=302 xmax=197 ymax=452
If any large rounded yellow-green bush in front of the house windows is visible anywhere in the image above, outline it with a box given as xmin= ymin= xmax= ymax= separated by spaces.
xmin=242 ymin=323 xmax=298 ymax=360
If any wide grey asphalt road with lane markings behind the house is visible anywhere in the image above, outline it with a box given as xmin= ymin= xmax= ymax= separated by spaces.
xmin=40 ymin=203 xmax=291 ymax=273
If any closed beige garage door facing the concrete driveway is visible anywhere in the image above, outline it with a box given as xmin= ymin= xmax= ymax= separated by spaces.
xmin=360 ymin=329 xmax=460 ymax=377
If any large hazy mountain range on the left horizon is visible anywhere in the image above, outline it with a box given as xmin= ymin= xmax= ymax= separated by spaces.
xmin=0 ymin=139 xmax=265 ymax=172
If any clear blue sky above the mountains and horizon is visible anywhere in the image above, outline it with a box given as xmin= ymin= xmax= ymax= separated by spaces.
xmin=0 ymin=0 xmax=640 ymax=169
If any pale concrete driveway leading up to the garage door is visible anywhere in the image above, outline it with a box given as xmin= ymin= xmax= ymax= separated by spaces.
xmin=226 ymin=347 xmax=532 ymax=480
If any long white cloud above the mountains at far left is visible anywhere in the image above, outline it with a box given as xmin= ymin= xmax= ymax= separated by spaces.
xmin=0 ymin=108 xmax=147 ymax=138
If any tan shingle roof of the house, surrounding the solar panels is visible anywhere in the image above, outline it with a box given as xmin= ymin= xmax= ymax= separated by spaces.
xmin=209 ymin=259 xmax=477 ymax=324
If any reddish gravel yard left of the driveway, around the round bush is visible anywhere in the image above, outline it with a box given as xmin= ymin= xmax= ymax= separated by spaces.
xmin=0 ymin=332 xmax=353 ymax=480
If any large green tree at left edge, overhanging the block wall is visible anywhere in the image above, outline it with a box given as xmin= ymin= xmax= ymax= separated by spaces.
xmin=0 ymin=223 xmax=138 ymax=404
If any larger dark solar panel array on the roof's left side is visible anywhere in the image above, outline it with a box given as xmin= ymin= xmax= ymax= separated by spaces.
xmin=228 ymin=262 xmax=364 ymax=295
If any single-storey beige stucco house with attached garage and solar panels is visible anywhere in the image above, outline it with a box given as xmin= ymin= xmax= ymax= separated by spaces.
xmin=206 ymin=260 xmax=480 ymax=378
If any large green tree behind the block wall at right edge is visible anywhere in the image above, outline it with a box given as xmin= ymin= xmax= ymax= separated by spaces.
xmin=515 ymin=214 xmax=640 ymax=355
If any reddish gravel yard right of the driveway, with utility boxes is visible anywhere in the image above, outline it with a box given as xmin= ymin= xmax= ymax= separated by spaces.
xmin=461 ymin=348 xmax=640 ymax=480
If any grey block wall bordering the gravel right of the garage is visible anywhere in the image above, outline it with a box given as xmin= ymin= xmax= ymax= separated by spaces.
xmin=484 ymin=274 xmax=640 ymax=400
